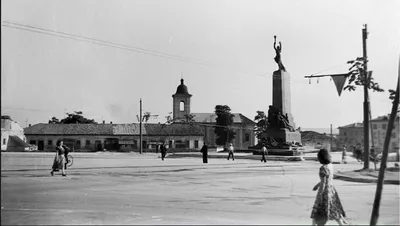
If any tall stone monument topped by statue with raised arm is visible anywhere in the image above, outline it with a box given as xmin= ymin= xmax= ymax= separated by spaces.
xmin=263 ymin=36 xmax=301 ymax=155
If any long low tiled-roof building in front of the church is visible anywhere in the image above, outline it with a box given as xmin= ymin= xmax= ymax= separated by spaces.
xmin=24 ymin=123 xmax=204 ymax=151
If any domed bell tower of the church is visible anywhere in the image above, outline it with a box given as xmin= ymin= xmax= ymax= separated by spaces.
xmin=172 ymin=78 xmax=192 ymax=120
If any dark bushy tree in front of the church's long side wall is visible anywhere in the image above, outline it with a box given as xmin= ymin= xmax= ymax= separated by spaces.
xmin=214 ymin=105 xmax=236 ymax=145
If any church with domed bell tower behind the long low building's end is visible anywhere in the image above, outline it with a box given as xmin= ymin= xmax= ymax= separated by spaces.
xmin=172 ymin=79 xmax=256 ymax=149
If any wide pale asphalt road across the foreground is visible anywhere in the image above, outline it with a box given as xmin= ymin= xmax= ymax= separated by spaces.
xmin=1 ymin=153 xmax=400 ymax=225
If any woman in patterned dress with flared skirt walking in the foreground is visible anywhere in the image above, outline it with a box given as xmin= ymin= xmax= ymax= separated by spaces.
xmin=311 ymin=149 xmax=347 ymax=225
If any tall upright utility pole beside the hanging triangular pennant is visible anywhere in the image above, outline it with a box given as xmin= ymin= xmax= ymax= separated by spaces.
xmin=362 ymin=24 xmax=370 ymax=169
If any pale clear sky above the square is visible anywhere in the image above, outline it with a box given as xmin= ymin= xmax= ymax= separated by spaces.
xmin=1 ymin=0 xmax=400 ymax=132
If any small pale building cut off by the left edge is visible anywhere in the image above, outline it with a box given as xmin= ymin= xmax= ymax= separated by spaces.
xmin=1 ymin=115 xmax=32 ymax=151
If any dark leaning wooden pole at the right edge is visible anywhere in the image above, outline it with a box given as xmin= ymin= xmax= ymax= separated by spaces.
xmin=370 ymin=55 xmax=400 ymax=226
